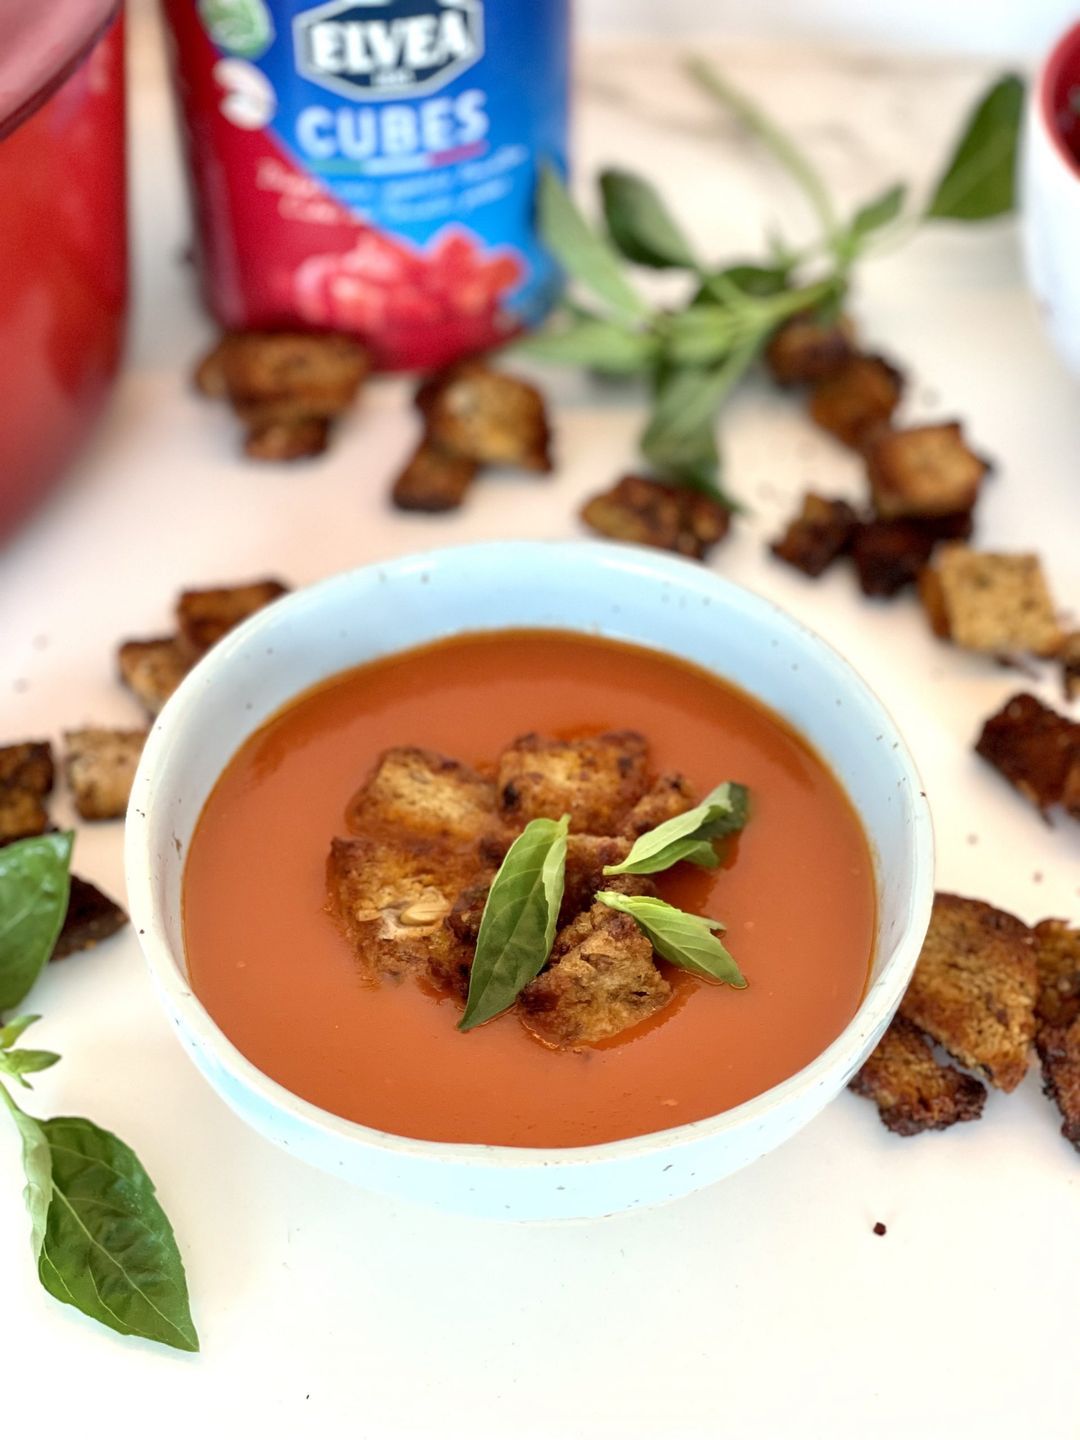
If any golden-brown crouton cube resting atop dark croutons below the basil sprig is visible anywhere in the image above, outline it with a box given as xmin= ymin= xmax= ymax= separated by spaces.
xmin=864 ymin=423 xmax=989 ymax=520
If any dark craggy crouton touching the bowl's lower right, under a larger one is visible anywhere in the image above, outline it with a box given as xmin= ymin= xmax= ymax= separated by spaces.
xmin=851 ymin=1015 xmax=986 ymax=1135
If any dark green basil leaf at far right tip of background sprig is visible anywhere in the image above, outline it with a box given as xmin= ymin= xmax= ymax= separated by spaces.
xmin=926 ymin=75 xmax=1024 ymax=220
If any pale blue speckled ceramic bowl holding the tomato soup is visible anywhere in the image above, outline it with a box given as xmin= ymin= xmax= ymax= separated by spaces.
xmin=127 ymin=541 xmax=933 ymax=1220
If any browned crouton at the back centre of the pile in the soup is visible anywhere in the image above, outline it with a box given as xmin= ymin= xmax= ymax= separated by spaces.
xmin=495 ymin=730 xmax=648 ymax=835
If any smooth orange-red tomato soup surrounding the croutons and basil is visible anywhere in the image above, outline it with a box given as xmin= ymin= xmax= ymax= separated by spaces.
xmin=183 ymin=631 xmax=876 ymax=1146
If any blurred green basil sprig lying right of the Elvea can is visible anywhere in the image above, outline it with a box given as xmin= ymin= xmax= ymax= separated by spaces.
xmin=517 ymin=59 xmax=1022 ymax=504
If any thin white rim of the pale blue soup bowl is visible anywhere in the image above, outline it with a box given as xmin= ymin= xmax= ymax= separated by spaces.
xmin=124 ymin=540 xmax=935 ymax=1171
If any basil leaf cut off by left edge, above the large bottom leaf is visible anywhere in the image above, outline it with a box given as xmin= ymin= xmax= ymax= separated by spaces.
xmin=0 ymin=832 xmax=72 ymax=1011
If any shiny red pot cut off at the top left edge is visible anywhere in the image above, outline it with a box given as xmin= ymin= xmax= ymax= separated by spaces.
xmin=0 ymin=0 xmax=127 ymax=533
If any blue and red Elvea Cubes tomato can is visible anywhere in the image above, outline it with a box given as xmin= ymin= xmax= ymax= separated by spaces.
xmin=164 ymin=0 xmax=569 ymax=369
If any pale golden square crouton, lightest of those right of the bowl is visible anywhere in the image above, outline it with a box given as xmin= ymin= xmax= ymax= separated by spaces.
xmin=920 ymin=544 xmax=1061 ymax=655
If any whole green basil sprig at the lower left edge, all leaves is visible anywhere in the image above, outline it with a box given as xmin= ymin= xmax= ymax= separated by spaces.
xmin=0 ymin=835 xmax=199 ymax=1351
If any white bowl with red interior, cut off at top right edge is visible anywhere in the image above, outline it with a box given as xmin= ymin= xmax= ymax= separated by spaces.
xmin=1021 ymin=24 xmax=1080 ymax=376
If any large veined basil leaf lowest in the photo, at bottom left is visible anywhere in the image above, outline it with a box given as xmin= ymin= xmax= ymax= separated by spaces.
xmin=37 ymin=1117 xmax=199 ymax=1351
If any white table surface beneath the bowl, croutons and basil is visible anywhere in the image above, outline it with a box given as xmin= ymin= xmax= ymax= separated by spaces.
xmin=0 ymin=14 xmax=1080 ymax=1440
